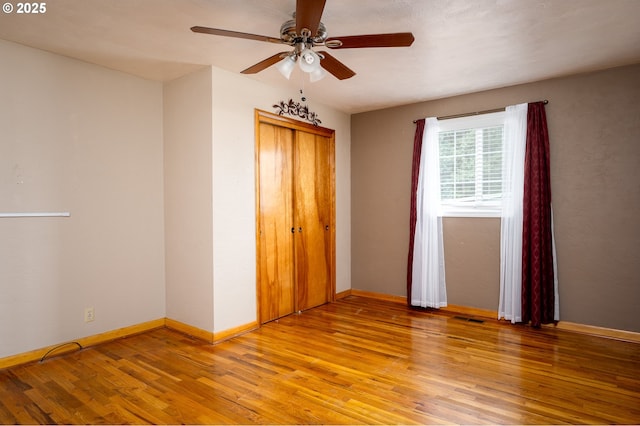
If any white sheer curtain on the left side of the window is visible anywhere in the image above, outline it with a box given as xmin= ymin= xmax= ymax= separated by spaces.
xmin=411 ymin=118 xmax=447 ymax=308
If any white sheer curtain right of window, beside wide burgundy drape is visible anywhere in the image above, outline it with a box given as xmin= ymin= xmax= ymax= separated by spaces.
xmin=498 ymin=103 xmax=528 ymax=323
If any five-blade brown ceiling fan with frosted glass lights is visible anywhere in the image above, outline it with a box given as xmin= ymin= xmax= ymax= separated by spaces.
xmin=191 ymin=0 xmax=414 ymax=82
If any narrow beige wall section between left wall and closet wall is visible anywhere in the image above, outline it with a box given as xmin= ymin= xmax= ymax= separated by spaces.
xmin=163 ymin=68 xmax=213 ymax=331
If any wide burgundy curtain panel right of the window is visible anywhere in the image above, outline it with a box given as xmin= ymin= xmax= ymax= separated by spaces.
xmin=522 ymin=102 xmax=555 ymax=327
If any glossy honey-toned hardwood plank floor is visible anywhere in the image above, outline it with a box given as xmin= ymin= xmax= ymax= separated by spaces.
xmin=0 ymin=296 xmax=640 ymax=424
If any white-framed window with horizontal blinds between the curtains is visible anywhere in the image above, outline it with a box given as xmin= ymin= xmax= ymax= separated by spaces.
xmin=438 ymin=112 xmax=504 ymax=217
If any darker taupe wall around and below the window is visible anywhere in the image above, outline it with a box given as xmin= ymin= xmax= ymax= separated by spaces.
xmin=351 ymin=65 xmax=640 ymax=331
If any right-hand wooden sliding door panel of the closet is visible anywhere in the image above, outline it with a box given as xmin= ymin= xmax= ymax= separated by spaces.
xmin=293 ymin=131 xmax=331 ymax=310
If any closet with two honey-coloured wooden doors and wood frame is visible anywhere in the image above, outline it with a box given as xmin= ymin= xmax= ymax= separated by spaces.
xmin=255 ymin=110 xmax=335 ymax=324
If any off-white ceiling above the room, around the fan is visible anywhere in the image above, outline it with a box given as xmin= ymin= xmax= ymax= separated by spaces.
xmin=0 ymin=0 xmax=640 ymax=113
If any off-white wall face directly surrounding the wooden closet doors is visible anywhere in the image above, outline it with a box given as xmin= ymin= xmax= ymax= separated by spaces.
xmin=212 ymin=68 xmax=351 ymax=332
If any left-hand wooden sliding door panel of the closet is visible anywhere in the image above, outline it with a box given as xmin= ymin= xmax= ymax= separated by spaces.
xmin=258 ymin=123 xmax=295 ymax=323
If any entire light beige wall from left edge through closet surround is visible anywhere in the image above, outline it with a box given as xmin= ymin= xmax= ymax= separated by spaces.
xmin=0 ymin=41 xmax=351 ymax=358
